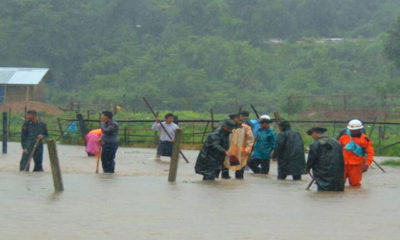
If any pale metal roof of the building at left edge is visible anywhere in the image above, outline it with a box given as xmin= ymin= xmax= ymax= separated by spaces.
xmin=0 ymin=67 xmax=49 ymax=85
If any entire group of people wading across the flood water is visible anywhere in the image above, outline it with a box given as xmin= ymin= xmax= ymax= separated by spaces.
xmin=20 ymin=110 xmax=374 ymax=191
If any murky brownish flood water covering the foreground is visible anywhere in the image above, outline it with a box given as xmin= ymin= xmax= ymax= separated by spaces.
xmin=0 ymin=143 xmax=400 ymax=240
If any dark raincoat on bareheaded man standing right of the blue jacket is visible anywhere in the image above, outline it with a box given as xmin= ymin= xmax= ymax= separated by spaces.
xmin=274 ymin=123 xmax=306 ymax=176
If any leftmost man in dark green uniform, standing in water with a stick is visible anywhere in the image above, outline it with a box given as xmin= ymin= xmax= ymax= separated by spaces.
xmin=19 ymin=110 xmax=48 ymax=172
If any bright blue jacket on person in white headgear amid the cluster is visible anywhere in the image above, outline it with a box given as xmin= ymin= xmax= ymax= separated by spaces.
xmin=251 ymin=128 xmax=277 ymax=159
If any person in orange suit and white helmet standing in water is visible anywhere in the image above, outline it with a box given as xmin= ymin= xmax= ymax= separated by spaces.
xmin=339 ymin=119 xmax=374 ymax=187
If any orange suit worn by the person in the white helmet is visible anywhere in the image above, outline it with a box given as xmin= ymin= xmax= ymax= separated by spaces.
xmin=339 ymin=134 xmax=375 ymax=186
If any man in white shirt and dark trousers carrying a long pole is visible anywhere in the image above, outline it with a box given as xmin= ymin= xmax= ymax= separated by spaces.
xmin=152 ymin=113 xmax=179 ymax=160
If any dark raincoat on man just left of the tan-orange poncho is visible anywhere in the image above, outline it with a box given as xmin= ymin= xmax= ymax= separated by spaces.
xmin=195 ymin=128 xmax=230 ymax=178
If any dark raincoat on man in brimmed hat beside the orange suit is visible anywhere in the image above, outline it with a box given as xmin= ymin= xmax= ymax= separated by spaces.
xmin=307 ymin=135 xmax=344 ymax=191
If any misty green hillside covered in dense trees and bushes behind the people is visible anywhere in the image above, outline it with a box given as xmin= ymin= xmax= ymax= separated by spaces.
xmin=0 ymin=0 xmax=400 ymax=112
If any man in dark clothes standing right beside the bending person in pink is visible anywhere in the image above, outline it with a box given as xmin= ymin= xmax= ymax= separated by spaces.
xmin=100 ymin=111 xmax=119 ymax=173
